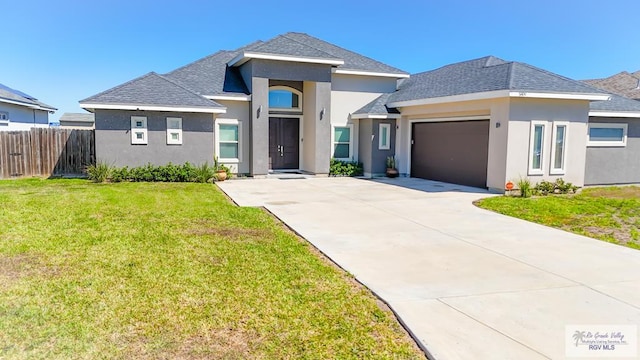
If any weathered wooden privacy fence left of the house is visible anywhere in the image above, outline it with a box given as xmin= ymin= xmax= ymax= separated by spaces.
xmin=0 ymin=128 xmax=96 ymax=179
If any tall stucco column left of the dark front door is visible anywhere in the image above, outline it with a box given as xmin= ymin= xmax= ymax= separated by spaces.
xmin=249 ymin=77 xmax=269 ymax=176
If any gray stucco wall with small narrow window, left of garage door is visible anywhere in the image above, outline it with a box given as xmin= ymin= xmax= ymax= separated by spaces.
xmin=358 ymin=119 xmax=396 ymax=176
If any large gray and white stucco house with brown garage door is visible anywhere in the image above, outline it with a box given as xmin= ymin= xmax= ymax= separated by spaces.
xmin=80 ymin=33 xmax=640 ymax=191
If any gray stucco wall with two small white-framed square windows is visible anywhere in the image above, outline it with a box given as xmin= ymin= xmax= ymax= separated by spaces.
xmin=95 ymin=110 xmax=214 ymax=167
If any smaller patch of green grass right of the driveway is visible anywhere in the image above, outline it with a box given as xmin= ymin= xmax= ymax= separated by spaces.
xmin=476 ymin=186 xmax=640 ymax=249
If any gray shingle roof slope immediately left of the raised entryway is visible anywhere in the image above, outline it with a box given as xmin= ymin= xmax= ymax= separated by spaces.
xmin=165 ymin=50 xmax=250 ymax=95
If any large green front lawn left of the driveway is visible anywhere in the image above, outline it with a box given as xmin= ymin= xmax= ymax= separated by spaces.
xmin=0 ymin=179 xmax=424 ymax=359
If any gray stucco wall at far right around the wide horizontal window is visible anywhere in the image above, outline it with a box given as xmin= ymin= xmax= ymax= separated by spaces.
xmin=584 ymin=117 xmax=640 ymax=185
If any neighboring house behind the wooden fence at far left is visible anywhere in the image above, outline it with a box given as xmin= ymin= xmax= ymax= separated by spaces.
xmin=0 ymin=84 xmax=57 ymax=131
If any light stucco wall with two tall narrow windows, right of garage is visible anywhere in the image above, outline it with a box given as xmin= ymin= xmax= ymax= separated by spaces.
xmin=506 ymin=99 xmax=589 ymax=186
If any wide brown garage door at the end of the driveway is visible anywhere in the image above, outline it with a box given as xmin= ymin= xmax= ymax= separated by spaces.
xmin=411 ymin=120 xmax=489 ymax=188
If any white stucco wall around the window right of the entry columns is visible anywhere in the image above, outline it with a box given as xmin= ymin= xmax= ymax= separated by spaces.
xmin=328 ymin=74 xmax=397 ymax=160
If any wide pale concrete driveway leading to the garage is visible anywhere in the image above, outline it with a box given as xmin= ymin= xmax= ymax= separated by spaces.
xmin=218 ymin=178 xmax=640 ymax=359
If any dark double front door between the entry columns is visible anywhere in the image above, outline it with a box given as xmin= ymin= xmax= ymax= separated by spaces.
xmin=269 ymin=117 xmax=300 ymax=170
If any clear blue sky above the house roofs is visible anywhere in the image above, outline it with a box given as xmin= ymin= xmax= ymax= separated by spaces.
xmin=0 ymin=0 xmax=640 ymax=120
